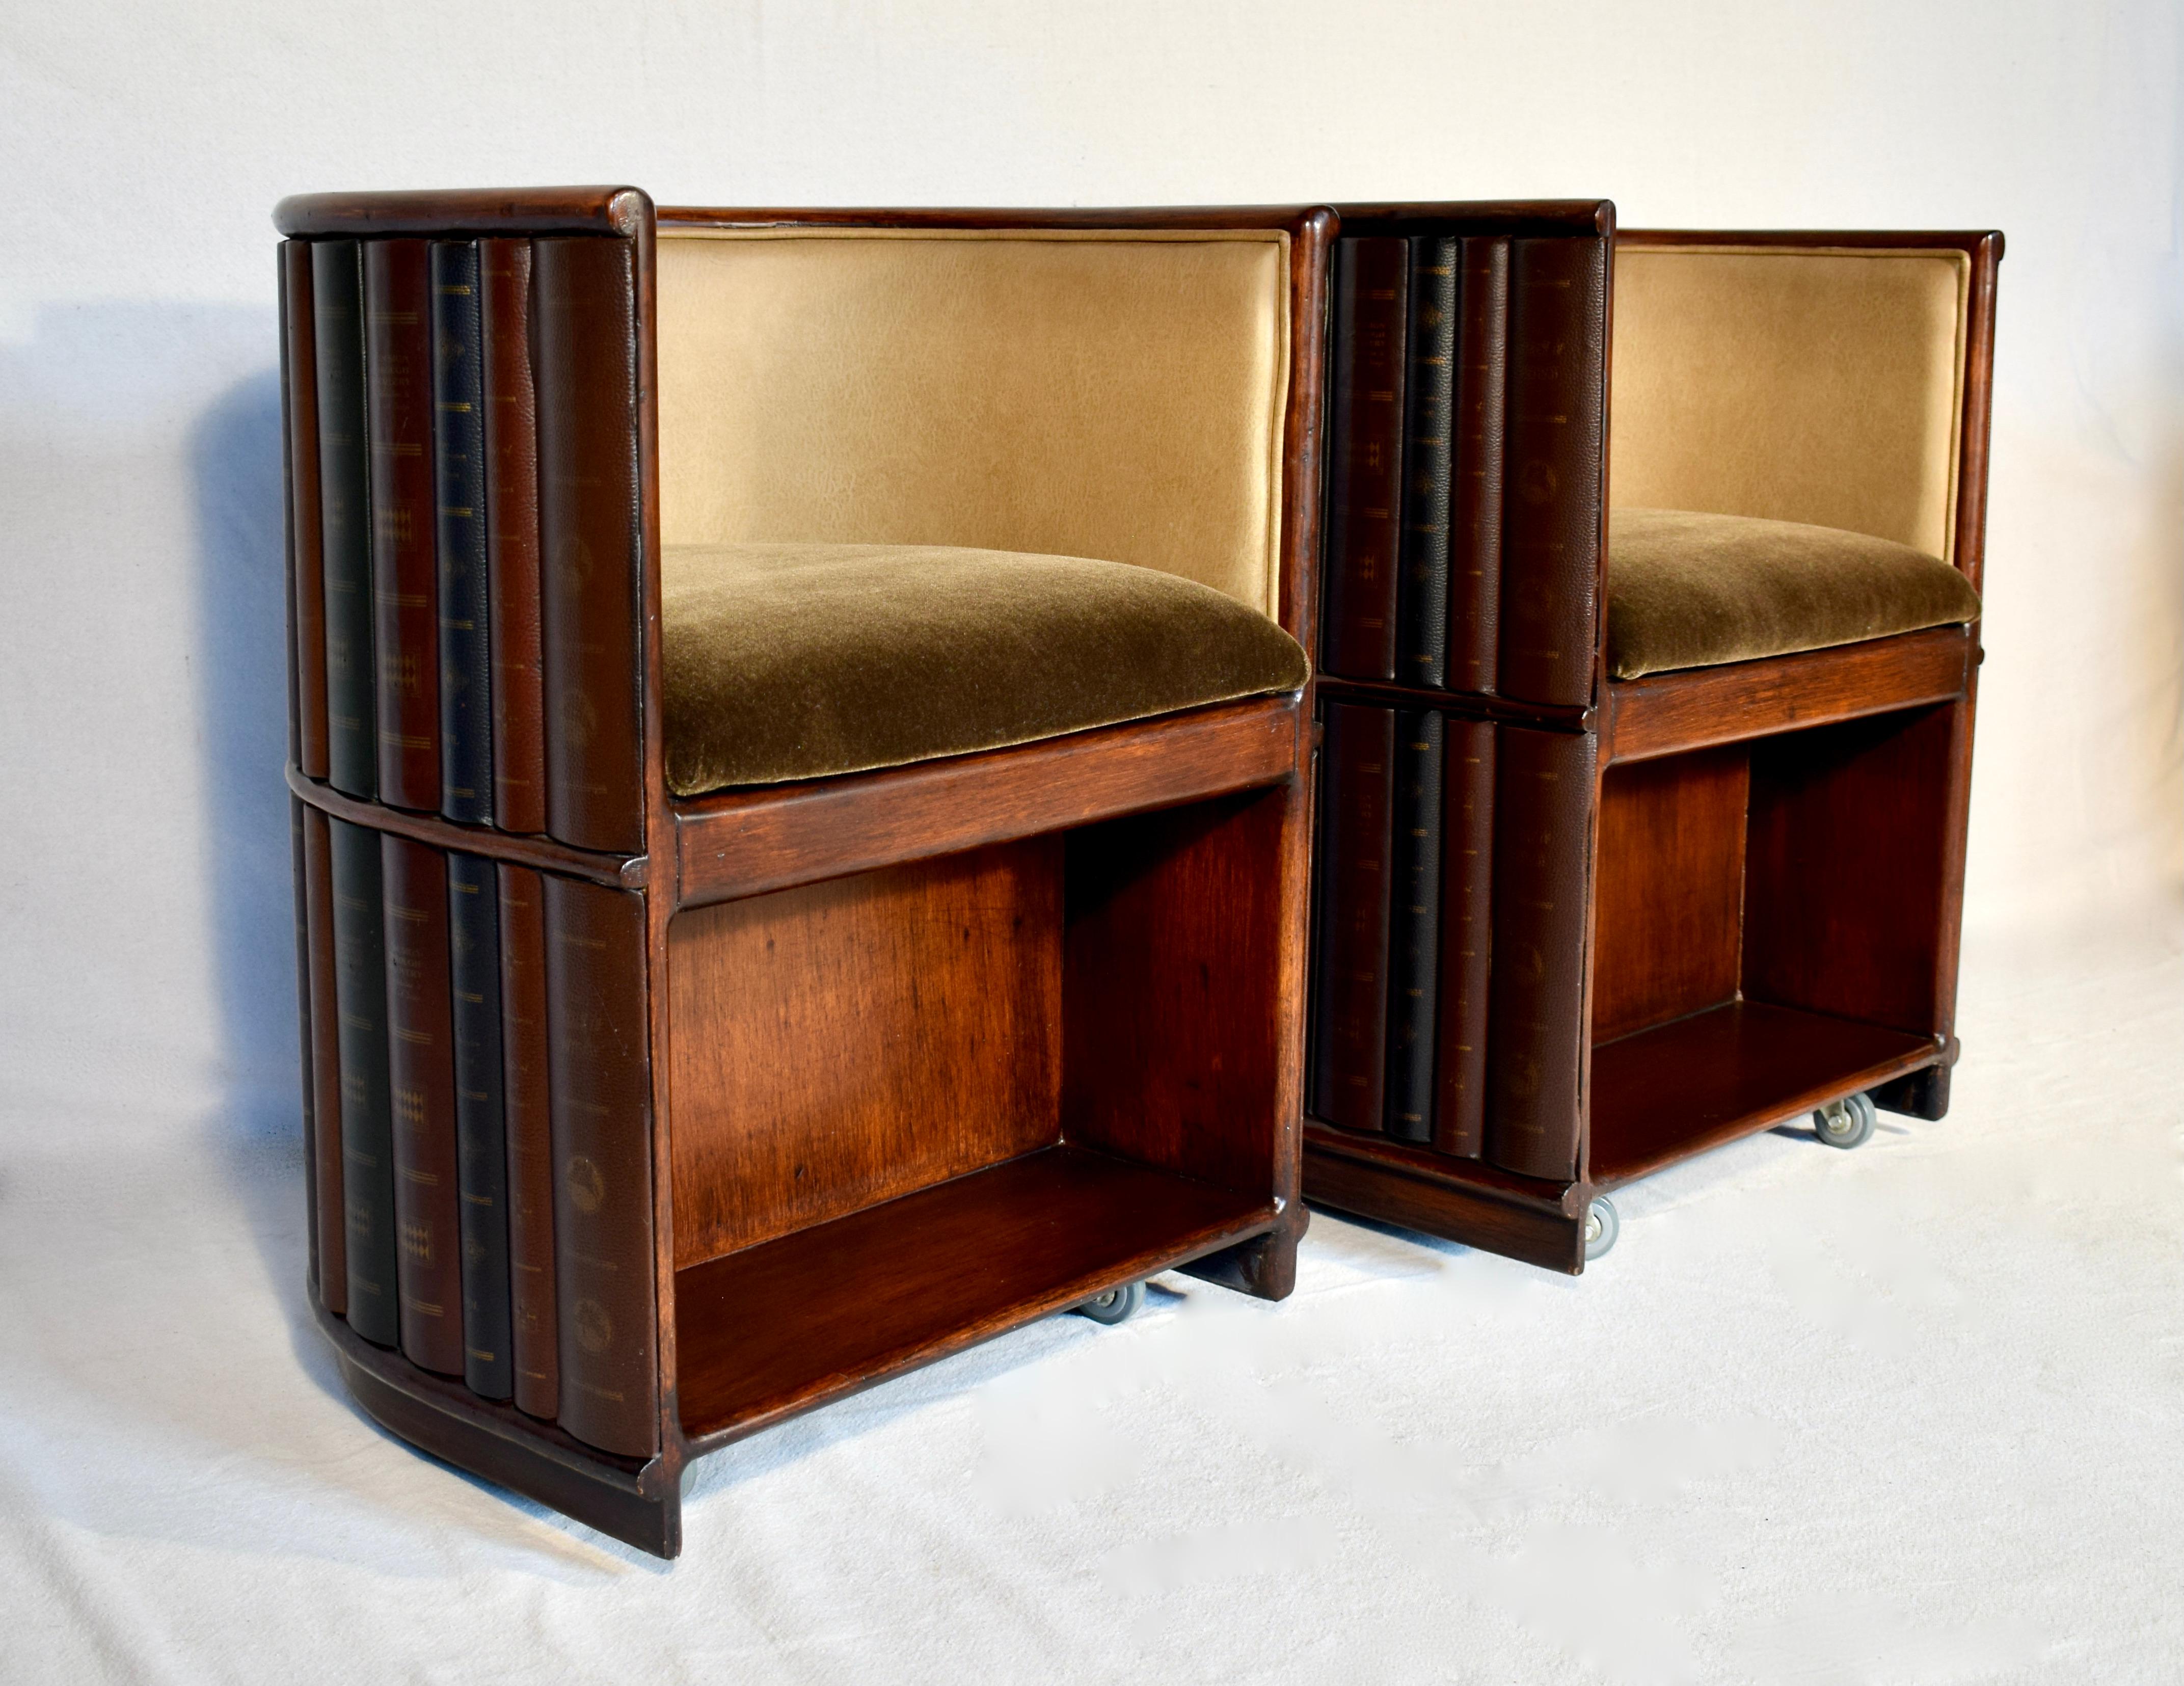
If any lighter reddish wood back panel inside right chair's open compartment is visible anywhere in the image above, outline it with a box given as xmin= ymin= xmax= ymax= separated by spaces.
xmin=1592 ymin=747 xmax=1751 ymax=1042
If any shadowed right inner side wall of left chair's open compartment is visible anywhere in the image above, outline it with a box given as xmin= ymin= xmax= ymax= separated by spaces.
xmin=1061 ymin=782 xmax=1302 ymax=1197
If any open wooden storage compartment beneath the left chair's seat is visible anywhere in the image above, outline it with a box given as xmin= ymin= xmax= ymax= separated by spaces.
xmin=668 ymin=782 xmax=1300 ymax=1450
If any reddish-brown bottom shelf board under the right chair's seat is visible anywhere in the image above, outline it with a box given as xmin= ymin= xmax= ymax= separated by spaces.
xmin=1592 ymin=1000 xmax=1942 ymax=1188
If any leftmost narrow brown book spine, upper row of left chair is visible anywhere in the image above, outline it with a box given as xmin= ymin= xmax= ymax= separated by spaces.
xmin=280 ymin=240 xmax=338 ymax=777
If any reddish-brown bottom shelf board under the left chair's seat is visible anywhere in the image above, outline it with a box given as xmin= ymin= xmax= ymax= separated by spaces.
xmin=675 ymin=1144 xmax=1276 ymax=1452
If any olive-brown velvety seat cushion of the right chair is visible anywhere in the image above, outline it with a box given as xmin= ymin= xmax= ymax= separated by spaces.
xmin=1607 ymin=509 xmax=1979 ymax=679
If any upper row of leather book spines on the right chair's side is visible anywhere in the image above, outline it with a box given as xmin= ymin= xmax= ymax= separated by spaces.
xmin=1322 ymin=234 xmax=1607 ymax=705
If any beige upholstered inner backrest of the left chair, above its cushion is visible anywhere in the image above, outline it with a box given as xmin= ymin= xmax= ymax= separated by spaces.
xmin=660 ymin=229 xmax=1288 ymax=616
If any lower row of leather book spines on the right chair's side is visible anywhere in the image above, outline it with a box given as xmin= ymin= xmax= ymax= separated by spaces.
xmin=1310 ymin=703 xmax=1597 ymax=1182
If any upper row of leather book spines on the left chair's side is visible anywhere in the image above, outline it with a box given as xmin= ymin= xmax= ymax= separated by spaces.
xmin=280 ymin=236 xmax=644 ymax=854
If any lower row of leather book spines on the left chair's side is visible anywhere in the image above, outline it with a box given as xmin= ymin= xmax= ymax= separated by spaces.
xmin=295 ymin=801 xmax=655 ymax=1452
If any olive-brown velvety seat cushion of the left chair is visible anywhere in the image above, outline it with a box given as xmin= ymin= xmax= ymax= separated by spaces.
xmin=660 ymin=544 xmax=1308 ymax=797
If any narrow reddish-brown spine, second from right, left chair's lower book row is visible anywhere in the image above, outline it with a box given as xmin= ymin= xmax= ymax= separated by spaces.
xmin=500 ymin=861 xmax=561 ymax=1420
